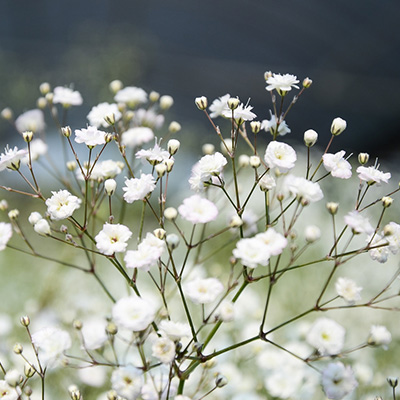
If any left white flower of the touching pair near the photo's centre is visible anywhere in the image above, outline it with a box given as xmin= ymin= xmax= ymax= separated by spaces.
xmin=233 ymin=237 xmax=271 ymax=268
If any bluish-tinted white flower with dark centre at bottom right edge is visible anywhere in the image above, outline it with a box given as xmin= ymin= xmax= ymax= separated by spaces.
xmin=322 ymin=362 xmax=358 ymax=400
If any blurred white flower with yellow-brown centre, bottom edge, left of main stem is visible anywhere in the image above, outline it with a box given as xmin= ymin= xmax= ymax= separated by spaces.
xmin=111 ymin=365 xmax=143 ymax=400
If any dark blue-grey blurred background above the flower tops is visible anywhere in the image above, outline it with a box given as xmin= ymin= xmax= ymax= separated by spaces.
xmin=0 ymin=0 xmax=400 ymax=160
